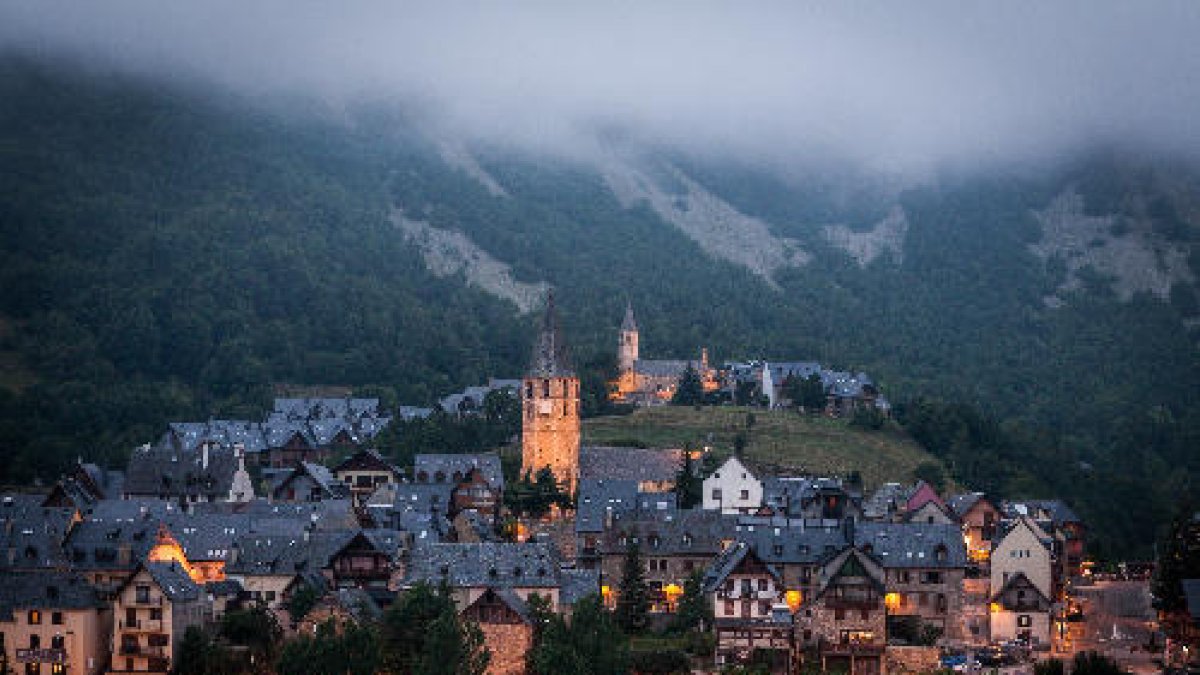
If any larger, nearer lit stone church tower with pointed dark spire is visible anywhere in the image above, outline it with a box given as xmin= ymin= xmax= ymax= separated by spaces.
xmin=521 ymin=291 xmax=580 ymax=494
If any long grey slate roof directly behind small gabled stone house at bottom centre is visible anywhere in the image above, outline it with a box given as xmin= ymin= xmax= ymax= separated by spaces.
xmin=404 ymin=542 xmax=562 ymax=589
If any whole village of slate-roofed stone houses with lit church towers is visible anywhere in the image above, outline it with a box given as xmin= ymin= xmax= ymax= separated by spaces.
xmin=0 ymin=297 xmax=1104 ymax=675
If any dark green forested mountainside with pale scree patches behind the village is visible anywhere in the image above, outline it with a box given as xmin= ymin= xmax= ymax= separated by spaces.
xmin=0 ymin=58 xmax=1200 ymax=555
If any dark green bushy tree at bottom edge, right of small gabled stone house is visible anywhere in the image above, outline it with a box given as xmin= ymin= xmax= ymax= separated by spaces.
xmin=526 ymin=595 xmax=630 ymax=675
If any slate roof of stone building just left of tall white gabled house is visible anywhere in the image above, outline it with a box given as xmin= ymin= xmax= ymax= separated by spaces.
xmin=854 ymin=522 xmax=967 ymax=568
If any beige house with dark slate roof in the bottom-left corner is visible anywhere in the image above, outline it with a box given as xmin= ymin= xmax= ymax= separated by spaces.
xmin=0 ymin=571 xmax=113 ymax=675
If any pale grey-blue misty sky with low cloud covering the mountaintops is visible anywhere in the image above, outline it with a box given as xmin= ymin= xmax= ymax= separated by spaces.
xmin=0 ymin=0 xmax=1200 ymax=166
